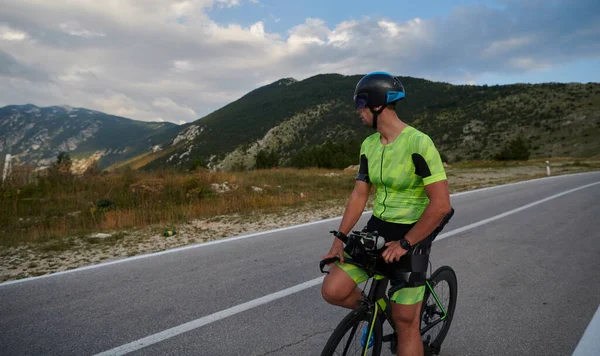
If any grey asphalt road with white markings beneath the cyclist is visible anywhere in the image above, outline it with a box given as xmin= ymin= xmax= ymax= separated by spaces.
xmin=0 ymin=172 xmax=600 ymax=356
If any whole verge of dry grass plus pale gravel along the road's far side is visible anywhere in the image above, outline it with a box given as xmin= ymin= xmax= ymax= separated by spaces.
xmin=0 ymin=158 xmax=600 ymax=282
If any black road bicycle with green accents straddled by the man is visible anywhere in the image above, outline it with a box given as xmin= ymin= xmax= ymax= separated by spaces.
xmin=320 ymin=210 xmax=458 ymax=356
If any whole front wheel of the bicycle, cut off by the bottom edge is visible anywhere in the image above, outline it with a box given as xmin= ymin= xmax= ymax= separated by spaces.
xmin=321 ymin=306 xmax=382 ymax=356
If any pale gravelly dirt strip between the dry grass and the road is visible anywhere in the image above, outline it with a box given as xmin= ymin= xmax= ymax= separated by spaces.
xmin=0 ymin=165 xmax=598 ymax=282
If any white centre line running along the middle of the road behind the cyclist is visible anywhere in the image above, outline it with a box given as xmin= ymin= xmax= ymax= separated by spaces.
xmin=94 ymin=182 xmax=600 ymax=356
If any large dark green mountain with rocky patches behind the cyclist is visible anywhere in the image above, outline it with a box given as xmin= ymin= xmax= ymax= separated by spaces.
xmin=132 ymin=74 xmax=600 ymax=169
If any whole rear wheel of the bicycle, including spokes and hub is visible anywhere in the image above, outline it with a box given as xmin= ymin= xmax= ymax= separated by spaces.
xmin=421 ymin=266 xmax=458 ymax=355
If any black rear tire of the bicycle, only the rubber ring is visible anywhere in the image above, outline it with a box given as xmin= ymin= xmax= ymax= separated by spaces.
xmin=421 ymin=266 xmax=458 ymax=355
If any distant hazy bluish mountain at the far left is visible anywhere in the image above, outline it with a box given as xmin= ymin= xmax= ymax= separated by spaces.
xmin=0 ymin=104 xmax=177 ymax=172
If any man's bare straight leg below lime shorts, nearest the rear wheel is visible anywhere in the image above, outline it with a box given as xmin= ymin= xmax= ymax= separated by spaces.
xmin=391 ymin=301 xmax=423 ymax=356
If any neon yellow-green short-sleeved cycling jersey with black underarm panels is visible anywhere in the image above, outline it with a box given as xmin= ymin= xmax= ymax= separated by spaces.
xmin=356 ymin=126 xmax=447 ymax=224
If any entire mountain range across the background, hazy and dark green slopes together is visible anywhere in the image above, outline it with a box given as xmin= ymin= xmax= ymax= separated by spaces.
xmin=0 ymin=74 xmax=600 ymax=174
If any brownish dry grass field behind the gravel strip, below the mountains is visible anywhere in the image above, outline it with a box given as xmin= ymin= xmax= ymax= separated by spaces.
xmin=0 ymin=158 xmax=600 ymax=246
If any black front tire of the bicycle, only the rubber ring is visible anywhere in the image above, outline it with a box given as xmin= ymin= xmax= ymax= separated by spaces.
xmin=321 ymin=306 xmax=383 ymax=356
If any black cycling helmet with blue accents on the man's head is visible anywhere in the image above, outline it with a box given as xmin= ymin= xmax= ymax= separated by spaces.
xmin=354 ymin=72 xmax=405 ymax=109
